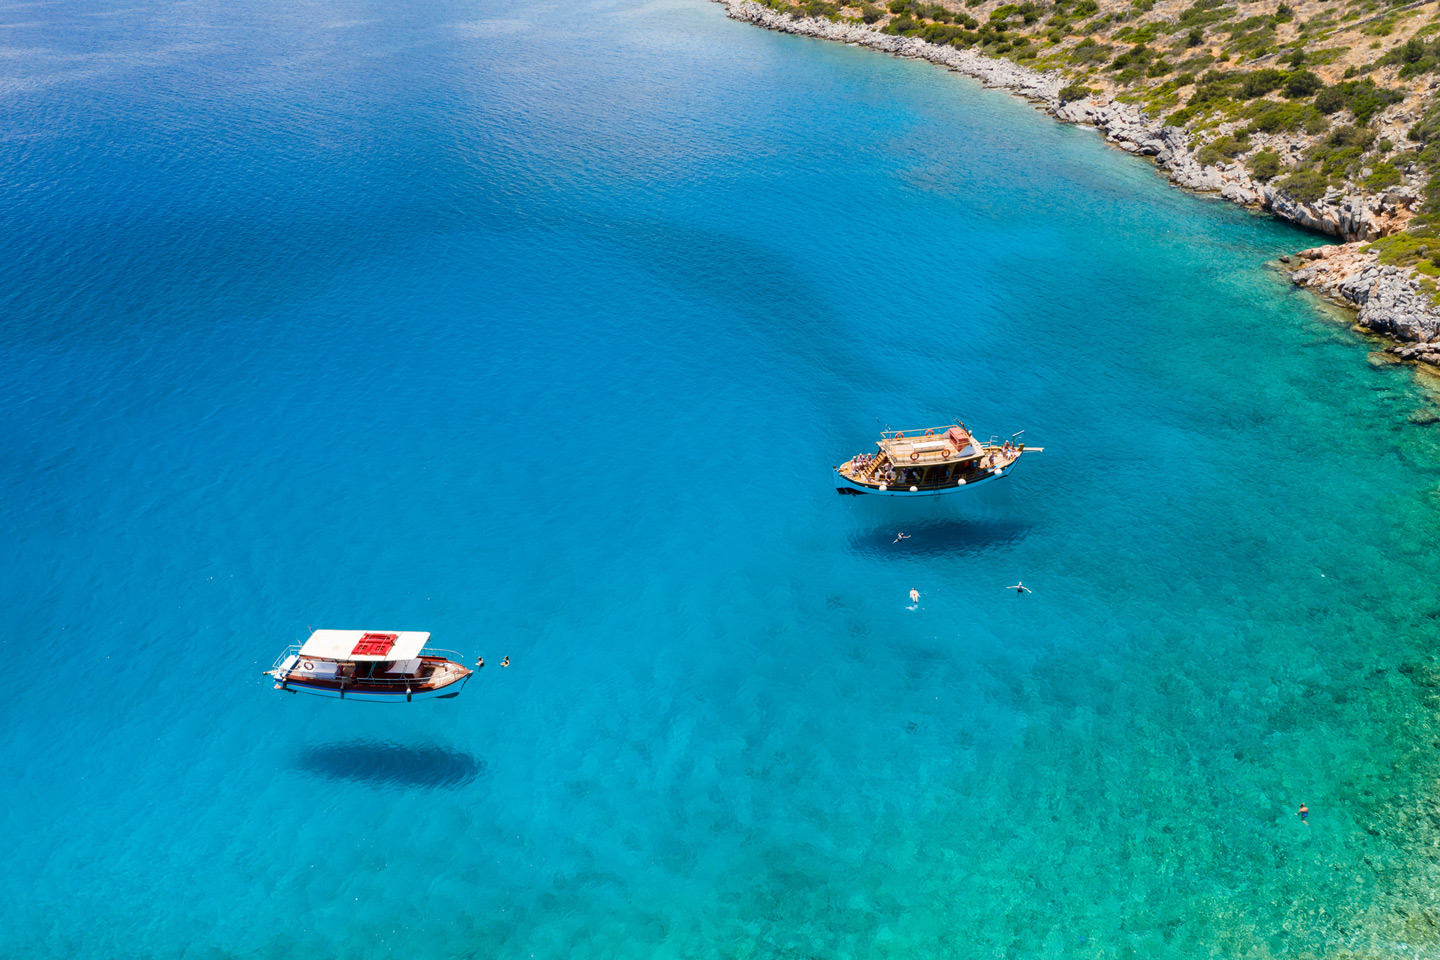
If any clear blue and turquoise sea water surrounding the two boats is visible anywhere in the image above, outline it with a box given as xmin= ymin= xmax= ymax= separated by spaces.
xmin=8 ymin=0 xmax=1440 ymax=960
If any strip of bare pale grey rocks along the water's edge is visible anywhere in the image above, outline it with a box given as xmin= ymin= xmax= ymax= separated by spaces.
xmin=716 ymin=0 xmax=1440 ymax=366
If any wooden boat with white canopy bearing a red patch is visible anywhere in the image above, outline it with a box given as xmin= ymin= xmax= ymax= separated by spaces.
xmin=265 ymin=630 xmax=474 ymax=704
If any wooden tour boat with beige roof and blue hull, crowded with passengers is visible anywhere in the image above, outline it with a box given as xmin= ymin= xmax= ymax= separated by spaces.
xmin=834 ymin=420 xmax=1044 ymax=497
